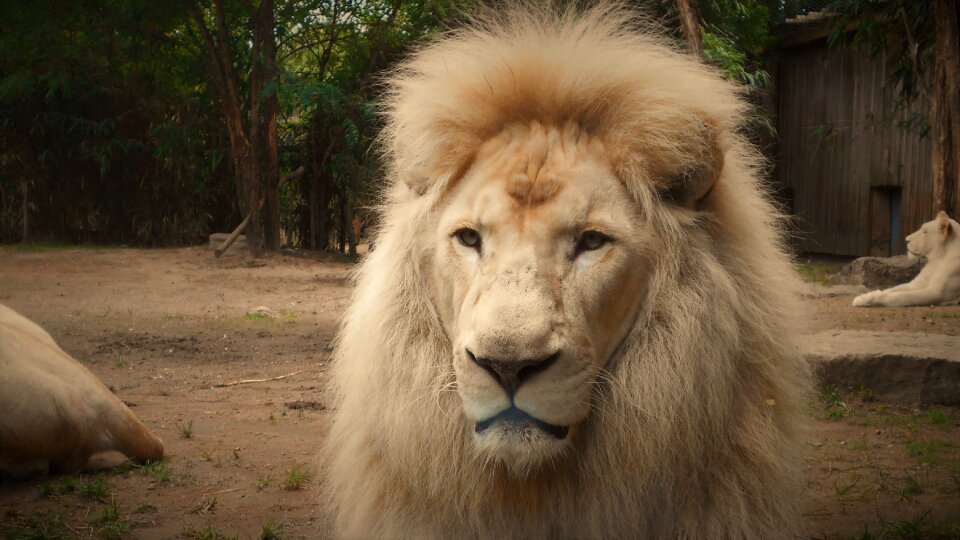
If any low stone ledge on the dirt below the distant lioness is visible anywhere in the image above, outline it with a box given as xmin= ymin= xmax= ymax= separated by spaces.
xmin=803 ymin=330 xmax=960 ymax=405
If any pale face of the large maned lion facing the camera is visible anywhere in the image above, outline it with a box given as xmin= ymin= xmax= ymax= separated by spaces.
xmin=433 ymin=124 xmax=655 ymax=471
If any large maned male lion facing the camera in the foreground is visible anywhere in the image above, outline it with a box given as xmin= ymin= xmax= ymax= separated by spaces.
xmin=324 ymin=5 xmax=809 ymax=539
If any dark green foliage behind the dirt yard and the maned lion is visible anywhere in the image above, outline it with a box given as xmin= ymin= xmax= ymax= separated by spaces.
xmin=0 ymin=0 xmax=783 ymax=249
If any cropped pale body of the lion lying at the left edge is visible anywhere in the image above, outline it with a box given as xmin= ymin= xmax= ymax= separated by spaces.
xmin=0 ymin=305 xmax=163 ymax=477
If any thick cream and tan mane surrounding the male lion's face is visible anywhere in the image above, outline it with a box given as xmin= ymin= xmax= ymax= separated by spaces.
xmin=323 ymin=4 xmax=809 ymax=538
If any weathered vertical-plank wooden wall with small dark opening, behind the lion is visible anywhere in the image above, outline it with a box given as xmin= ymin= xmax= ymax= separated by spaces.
xmin=776 ymin=39 xmax=933 ymax=256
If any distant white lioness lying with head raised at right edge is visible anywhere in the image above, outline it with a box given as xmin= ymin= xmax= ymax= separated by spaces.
xmin=853 ymin=211 xmax=960 ymax=307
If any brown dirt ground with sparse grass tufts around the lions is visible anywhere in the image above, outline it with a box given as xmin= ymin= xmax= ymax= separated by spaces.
xmin=0 ymin=247 xmax=960 ymax=539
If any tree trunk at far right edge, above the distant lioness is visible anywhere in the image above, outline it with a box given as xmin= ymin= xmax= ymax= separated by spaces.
xmin=930 ymin=0 xmax=960 ymax=218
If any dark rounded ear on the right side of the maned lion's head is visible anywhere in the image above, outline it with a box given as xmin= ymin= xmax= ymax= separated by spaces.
xmin=661 ymin=125 xmax=723 ymax=210
